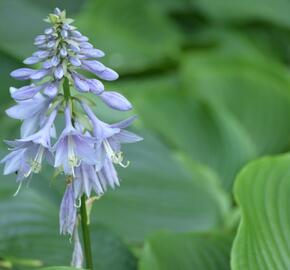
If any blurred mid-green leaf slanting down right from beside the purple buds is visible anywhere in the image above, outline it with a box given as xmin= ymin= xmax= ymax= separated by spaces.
xmin=112 ymin=74 xmax=255 ymax=188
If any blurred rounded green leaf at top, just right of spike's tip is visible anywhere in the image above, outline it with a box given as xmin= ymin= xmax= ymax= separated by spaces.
xmin=77 ymin=0 xmax=180 ymax=73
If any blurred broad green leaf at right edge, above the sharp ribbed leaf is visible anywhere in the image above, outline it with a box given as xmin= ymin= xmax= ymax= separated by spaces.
xmin=183 ymin=49 xmax=290 ymax=155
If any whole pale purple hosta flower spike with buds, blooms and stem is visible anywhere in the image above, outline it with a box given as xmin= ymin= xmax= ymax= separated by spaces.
xmin=1 ymin=8 xmax=142 ymax=269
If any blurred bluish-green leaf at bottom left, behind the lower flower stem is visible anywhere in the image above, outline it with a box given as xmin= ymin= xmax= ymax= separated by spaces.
xmin=0 ymin=172 xmax=136 ymax=270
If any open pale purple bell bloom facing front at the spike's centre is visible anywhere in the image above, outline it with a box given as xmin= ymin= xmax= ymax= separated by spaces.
xmin=53 ymin=106 xmax=96 ymax=176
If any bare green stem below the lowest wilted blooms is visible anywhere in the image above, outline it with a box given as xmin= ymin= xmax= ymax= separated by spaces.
xmin=80 ymin=195 xmax=94 ymax=270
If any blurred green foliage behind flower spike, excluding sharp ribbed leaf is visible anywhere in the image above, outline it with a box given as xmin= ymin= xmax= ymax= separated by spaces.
xmin=0 ymin=0 xmax=290 ymax=270
